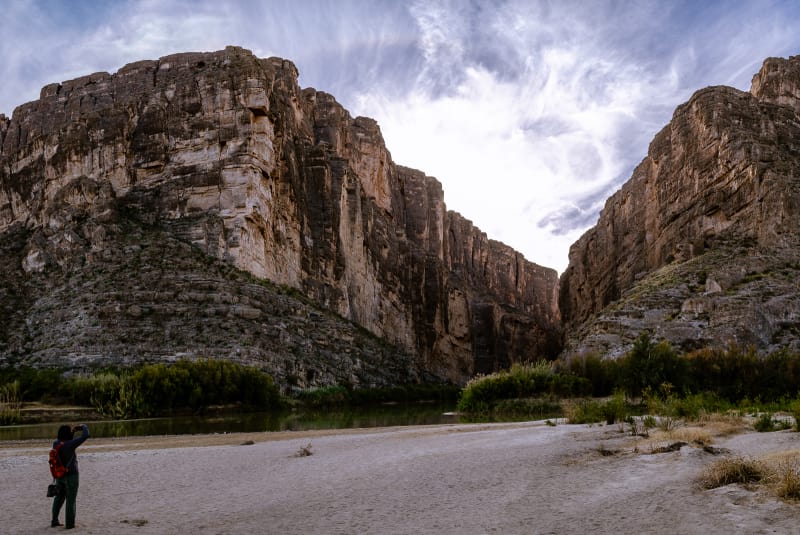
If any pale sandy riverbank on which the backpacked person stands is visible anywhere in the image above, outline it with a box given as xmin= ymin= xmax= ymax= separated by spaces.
xmin=0 ymin=422 xmax=800 ymax=535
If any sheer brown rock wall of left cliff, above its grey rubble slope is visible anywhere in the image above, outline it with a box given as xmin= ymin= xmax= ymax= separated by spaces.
xmin=0 ymin=47 xmax=560 ymax=381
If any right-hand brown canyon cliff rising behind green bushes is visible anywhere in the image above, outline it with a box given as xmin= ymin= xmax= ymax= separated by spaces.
xmin=560 ymin=56 xmax=800 ymax=356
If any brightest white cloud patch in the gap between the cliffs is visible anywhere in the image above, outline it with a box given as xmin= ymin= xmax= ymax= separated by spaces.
xmin=355 ymin=4 xmax=672 ymax=271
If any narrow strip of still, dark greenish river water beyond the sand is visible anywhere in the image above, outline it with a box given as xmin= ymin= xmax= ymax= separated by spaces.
xmin=0 ymin=403 xmax=459 ymax=440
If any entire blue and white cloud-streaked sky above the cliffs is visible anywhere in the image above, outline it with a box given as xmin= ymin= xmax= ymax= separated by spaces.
xmin=0 ymin=0 xmax=800 ymax=272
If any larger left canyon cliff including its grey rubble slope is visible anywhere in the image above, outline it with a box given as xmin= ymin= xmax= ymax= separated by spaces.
xmin=0 ymin=47 xmax=560 ymax=386
